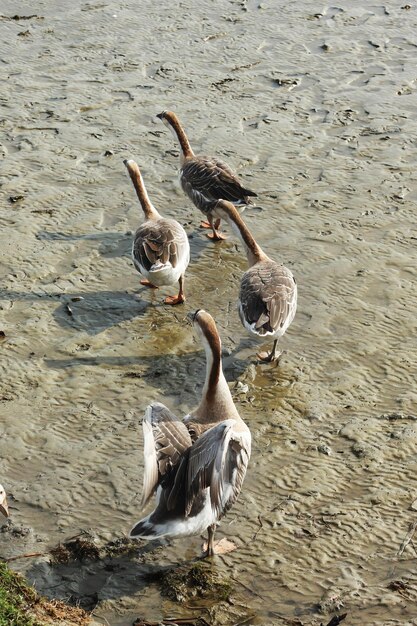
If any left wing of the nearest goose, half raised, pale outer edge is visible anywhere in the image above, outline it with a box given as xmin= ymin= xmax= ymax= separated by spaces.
xmin=142 ymin=402 xmax=192 ymax=507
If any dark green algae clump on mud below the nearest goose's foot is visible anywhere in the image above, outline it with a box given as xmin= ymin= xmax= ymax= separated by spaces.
xmin=160 ymin=563 xmax=232 ymax=602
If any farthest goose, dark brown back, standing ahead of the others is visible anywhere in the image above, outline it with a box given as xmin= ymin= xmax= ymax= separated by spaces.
xmin=157 ymin=111 xmax=257 ymax=241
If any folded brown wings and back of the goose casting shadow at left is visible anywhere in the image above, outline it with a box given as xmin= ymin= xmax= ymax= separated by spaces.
xmin=132 ymin=219 xmax=190 ymax=271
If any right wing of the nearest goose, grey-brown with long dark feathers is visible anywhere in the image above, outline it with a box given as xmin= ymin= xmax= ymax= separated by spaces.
xmin=185 ymin=419 xmax=251 ymax=518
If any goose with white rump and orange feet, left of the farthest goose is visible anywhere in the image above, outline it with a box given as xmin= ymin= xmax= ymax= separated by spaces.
xmin=123 ymin=159 xmax=190 ymax=305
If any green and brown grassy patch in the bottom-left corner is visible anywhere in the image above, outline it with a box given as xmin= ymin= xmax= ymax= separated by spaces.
xmin=0 ymin=562 xmax=91 ymax=626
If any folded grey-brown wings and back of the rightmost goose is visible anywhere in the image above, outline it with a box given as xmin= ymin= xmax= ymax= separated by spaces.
xmin=240 ymin=261 xmax=297 ymax=335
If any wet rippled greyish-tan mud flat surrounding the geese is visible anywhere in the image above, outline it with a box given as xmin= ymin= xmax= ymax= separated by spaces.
xmin=0 ymin=0 xmax=417 ymax=626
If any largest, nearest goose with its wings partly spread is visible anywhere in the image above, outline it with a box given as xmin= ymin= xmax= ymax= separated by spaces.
xmin=130 ymin=309 xmax=251 ymax=556
